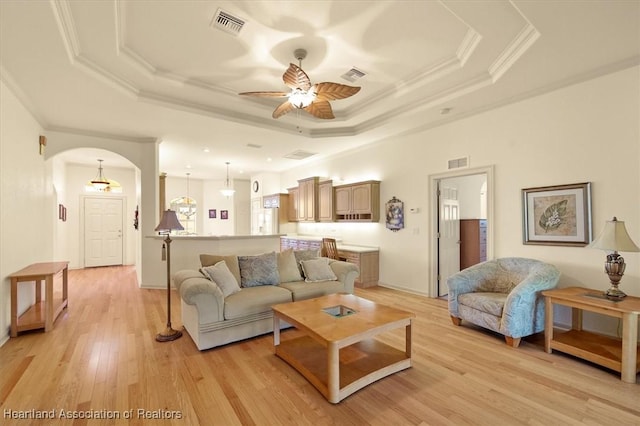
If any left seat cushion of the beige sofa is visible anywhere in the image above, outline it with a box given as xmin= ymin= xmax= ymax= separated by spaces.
xmin=224 ymin=285 xmax=293 ymax=320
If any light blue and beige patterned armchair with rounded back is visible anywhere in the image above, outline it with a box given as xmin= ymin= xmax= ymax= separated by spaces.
xmin=447 ymin=257 xmax=560 ymax=348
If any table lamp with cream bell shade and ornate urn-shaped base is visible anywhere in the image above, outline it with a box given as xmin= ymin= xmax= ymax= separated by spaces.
xmin=587 ymin=216 xmax=640 ymax=299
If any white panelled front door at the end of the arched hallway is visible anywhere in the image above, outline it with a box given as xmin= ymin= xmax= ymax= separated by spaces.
xmin=84 ymin=197 xmax=123 ymax=267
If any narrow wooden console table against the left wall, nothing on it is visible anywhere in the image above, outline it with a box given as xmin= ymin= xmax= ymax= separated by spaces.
xmin=9 ymin=262 xmax=69 ymax=337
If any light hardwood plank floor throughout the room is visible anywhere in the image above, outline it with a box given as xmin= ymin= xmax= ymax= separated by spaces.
xmin=0 ymin=267 xmax=640 ymax=425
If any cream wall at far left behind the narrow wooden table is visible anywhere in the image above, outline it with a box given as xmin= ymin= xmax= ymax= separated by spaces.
xmin=0 ymin=82 xmax=51 ymax=344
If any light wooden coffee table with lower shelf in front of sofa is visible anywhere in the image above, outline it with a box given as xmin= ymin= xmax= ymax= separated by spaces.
xmin=273 ymin=294 xmax=415 ymax=404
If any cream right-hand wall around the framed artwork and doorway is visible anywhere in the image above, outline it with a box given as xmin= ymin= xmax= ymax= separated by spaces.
xmin=282 ymin=67 xmax=640 ymax=306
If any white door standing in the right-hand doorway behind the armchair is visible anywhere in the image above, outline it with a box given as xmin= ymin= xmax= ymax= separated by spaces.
xmin=438 ymin=181 xmax=460 ymax=297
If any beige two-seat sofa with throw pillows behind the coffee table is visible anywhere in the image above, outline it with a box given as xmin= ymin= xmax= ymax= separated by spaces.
xmin=174 ymin=250 xmax=359 ymax=350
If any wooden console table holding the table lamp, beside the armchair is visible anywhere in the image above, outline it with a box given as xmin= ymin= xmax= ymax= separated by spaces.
xmin=542 ymin=287 xmax=640 ymax=383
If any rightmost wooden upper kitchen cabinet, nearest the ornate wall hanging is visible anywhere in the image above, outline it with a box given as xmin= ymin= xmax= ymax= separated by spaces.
xmin=334 ymin=181 xmax=380 ymax=222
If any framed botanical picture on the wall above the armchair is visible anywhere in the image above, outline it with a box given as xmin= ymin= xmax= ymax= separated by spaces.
xmin=522 ymin=182 xmax=592 ymax=246
